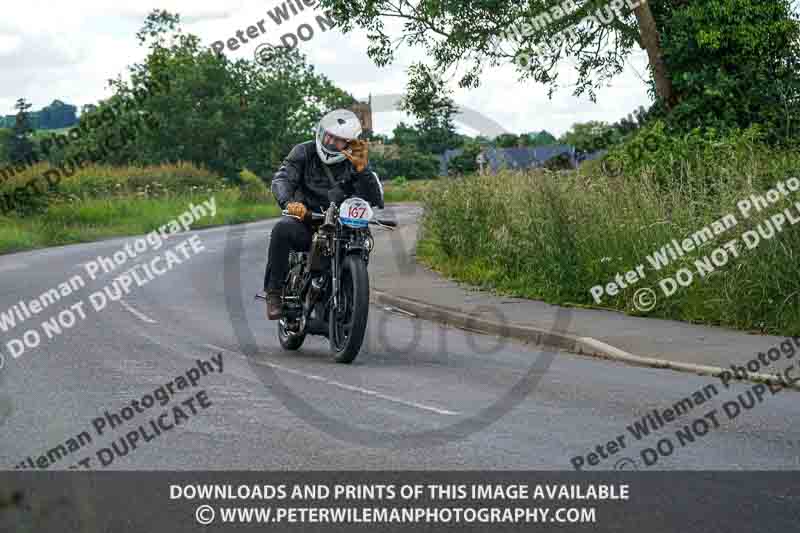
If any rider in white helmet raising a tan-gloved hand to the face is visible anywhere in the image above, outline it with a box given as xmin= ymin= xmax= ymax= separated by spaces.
xmin=264 ymin=109 xmax=384 ymax=320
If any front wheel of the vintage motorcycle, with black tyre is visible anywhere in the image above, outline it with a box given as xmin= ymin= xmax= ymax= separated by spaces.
xmin=328 ymin=255 xmax=369 ymax=364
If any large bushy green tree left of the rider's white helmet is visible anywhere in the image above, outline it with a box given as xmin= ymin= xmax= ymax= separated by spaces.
xmin=64 ymin=11 xmax=354 ymax=180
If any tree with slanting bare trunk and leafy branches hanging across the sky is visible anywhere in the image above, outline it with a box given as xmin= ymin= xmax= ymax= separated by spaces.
xmin=320 ymin=0 xmax=672 ymax=102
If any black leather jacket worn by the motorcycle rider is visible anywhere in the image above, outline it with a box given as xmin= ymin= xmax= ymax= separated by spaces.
xmin=271 ymin=141 xmax=383 ymax=212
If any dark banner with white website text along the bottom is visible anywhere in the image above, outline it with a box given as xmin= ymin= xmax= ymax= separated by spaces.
xmin=0 ymin=471 xmax=800 ymax=533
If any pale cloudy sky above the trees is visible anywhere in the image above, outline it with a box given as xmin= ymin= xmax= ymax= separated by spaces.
xmin=0 ymin=0 xmax=649 ymax=135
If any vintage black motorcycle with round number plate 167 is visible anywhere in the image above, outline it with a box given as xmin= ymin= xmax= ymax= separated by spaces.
xmin=270 ymin=197 xmax=397 ymax=364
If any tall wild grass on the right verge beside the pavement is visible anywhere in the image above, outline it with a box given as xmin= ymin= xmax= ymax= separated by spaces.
xmin=418 ymin=124 xmax=800 ymax=334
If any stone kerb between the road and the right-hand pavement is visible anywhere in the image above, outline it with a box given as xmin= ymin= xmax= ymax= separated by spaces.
xmin=372 ymin=289 xmax=800 ymax=390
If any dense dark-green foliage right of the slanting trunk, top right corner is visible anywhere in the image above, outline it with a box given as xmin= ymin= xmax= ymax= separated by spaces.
xmin=654 ymin=0 xmax=800 ymax=142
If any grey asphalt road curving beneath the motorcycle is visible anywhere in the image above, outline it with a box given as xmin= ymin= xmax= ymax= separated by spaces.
xmin=0 ymin=207 xmax=800 ymax=470
